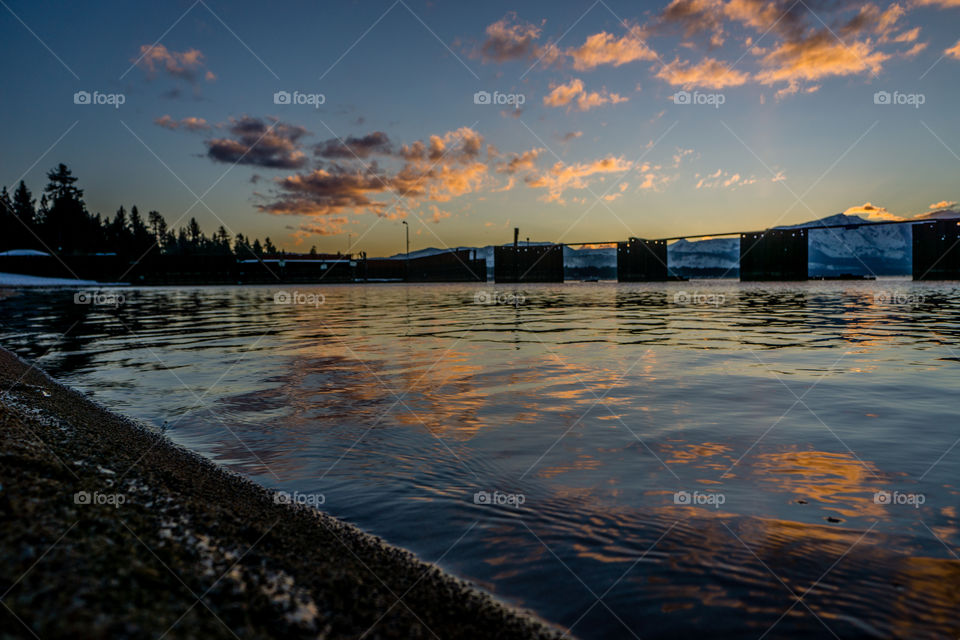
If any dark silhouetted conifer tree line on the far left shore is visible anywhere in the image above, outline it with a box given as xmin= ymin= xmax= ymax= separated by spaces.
xmin=0 ymin=163 xmax=296 ymax=259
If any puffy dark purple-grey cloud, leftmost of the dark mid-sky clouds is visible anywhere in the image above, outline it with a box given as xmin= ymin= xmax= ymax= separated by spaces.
xmin=205 ymin=116 xmax=308 ymax=169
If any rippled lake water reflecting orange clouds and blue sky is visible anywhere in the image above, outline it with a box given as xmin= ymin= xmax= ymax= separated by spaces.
xmin=0 ymin=279 xmax=960 ymax=640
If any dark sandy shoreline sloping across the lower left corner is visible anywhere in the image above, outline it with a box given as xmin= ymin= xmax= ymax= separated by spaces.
xmin=0 ymin=347 xmax=562 ymax=639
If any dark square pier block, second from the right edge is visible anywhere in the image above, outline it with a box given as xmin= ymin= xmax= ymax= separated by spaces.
xmin=740 ymin=229 xmax=809 ymax=282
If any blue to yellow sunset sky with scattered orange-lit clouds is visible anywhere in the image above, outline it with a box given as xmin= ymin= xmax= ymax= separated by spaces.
xmin=0 ymin=0 xmax=960 ymax=255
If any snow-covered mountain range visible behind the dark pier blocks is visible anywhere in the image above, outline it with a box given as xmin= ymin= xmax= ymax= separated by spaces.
xmin=391 ymin=209 xmax=960 ymax=279
